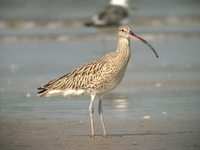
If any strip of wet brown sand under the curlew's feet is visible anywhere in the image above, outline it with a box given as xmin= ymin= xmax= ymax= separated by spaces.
xmin=0 ymin=116 xmax=200 ymax=150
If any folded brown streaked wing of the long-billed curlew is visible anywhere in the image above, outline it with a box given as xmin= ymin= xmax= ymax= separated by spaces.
xmin=39 ymin=61 xmax=111 ymax=91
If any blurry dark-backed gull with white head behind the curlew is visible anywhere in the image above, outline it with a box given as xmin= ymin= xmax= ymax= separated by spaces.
xmin=85 ymin=0 xmax=137 ymax=26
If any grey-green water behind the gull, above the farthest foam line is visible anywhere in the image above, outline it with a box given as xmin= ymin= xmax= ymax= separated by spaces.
xmin=0 ymin=0 xmax=200 ymax=20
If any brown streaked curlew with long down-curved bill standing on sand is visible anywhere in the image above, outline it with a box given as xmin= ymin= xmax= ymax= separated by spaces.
xmin=38 ymin=26 xmax=158 ymax=138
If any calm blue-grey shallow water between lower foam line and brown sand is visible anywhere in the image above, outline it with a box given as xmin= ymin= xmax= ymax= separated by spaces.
xmin=0 ymin=39 xmax=200 ymax=119
